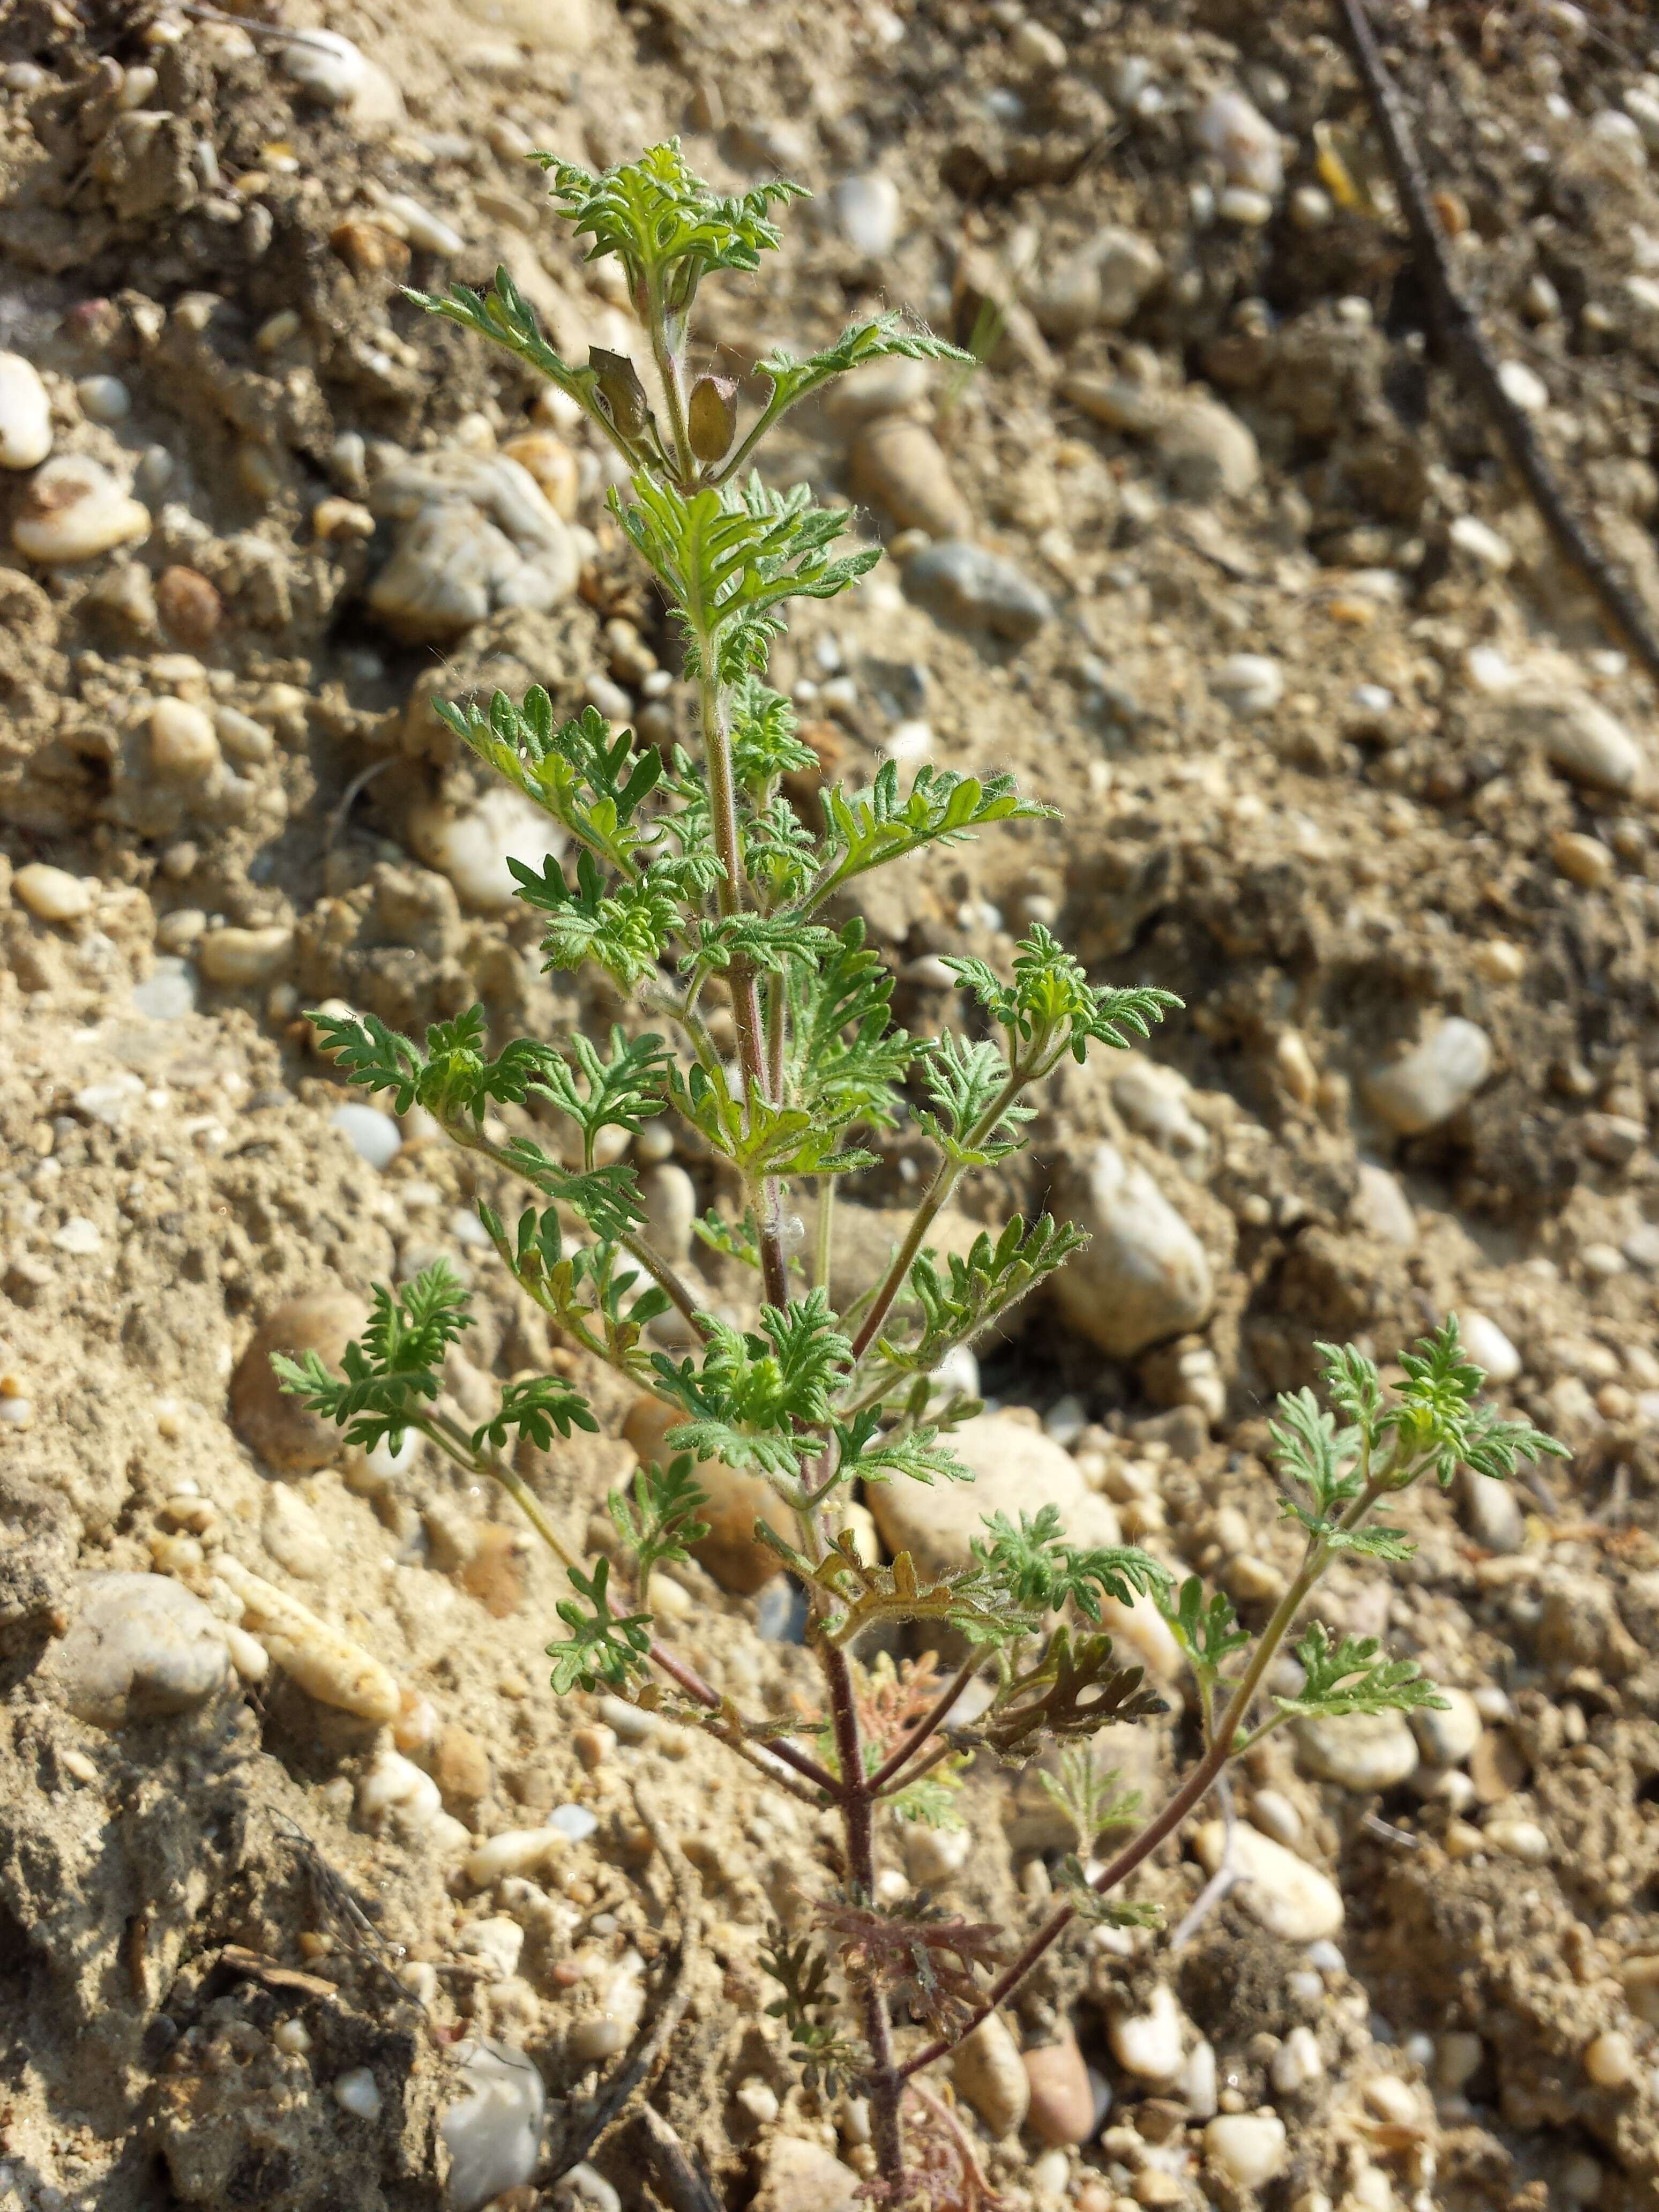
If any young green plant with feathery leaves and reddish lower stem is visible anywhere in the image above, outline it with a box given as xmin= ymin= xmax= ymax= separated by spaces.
xmin=279 ymin=144 xmax=1555 ymax=2203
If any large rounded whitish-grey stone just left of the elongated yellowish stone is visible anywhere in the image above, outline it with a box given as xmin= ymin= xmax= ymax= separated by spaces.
xmin=47 ymin=1573 xmax=228 ymax=1728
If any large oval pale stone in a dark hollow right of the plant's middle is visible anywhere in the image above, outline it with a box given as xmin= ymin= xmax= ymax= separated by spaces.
xmin=1053 ymin=1144 xmax=1214 ymax=1361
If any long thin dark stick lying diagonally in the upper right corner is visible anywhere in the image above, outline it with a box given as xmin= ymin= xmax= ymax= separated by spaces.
xmin=1336 ymin=0 xmax=1659 ymax=684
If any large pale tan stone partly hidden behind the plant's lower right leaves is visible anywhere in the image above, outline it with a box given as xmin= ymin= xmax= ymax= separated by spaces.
xmin=869 ymin=1414 xmax=1119 ymax=1575
